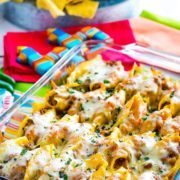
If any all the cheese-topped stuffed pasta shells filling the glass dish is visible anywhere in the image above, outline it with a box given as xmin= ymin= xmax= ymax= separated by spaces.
xmin=0 ymin=55 xmax=180 ymax=180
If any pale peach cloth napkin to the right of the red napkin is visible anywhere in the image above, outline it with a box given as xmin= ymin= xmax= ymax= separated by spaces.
xmin=130 ymin=17 xmax=180 ymax=56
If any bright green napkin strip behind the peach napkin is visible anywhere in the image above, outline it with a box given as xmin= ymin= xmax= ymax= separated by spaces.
xmin=141 ymin=10 xmax=180 ymax=29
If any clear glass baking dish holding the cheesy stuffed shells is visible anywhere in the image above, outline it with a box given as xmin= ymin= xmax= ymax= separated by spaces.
xmin=0 ymin=41 xmax=180 ymax=179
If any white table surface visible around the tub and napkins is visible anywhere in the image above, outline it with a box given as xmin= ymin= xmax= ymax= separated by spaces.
xmin=0 ymin=0 xmax=180 ymax=66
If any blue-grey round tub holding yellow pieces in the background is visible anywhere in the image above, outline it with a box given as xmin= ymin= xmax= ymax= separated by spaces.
xmin=4 ymin=0 xmax=140 ymax=30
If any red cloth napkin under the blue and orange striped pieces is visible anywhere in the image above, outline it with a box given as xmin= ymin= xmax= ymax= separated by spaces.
xmin=4 ymin=20 xmax=135 ymax=82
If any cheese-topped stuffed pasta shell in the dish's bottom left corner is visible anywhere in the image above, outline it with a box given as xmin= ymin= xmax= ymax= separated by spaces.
xmin=0 ymin=137 xmax=37 ymax=180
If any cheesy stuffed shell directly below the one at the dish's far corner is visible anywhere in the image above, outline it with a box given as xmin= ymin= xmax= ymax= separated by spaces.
xmin=72 ymin=89 xmax=125 ymax=126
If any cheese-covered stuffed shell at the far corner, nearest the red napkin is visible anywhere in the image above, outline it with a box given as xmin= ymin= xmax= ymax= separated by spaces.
xmin=67 ymin=56 xmax=127 ymax=90
